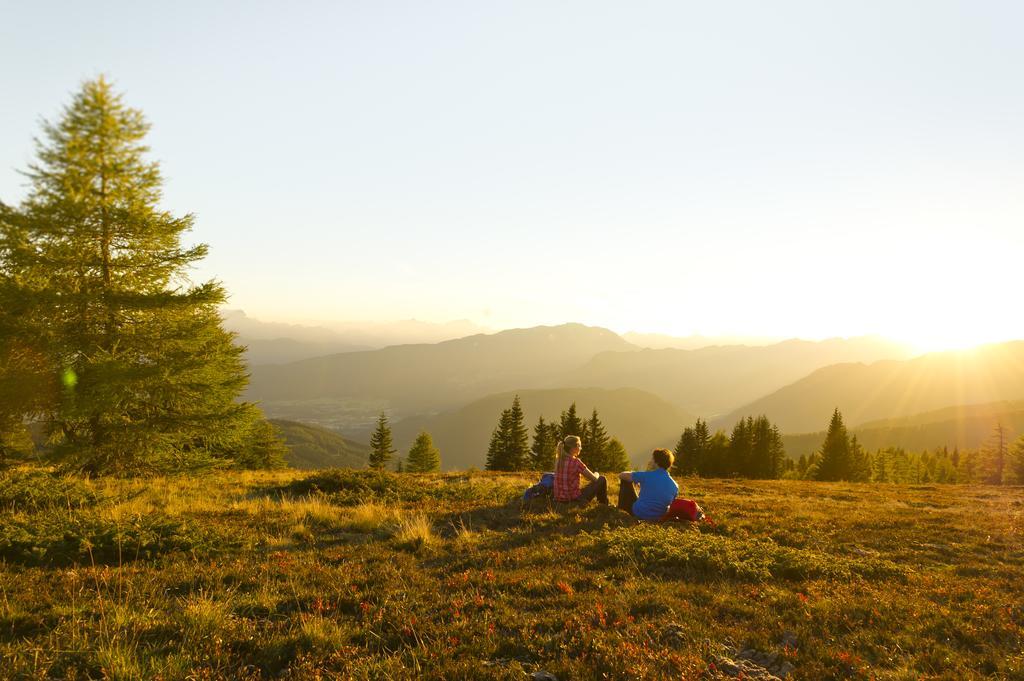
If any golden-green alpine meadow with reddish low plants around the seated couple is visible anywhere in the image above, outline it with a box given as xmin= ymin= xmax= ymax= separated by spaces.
xmin=0 ymin=469 xmax=1024 ymax=681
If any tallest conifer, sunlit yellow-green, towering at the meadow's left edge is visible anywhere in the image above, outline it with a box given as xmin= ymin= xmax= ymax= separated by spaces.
xmin=0 ymin=78 xmax=283 ymax=472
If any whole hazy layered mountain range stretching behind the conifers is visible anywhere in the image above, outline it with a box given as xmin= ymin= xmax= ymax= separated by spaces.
xmin=237 ymin=324 xmax=1024 ymax=468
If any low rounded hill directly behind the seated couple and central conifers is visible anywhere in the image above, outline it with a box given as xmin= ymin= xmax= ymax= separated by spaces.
xmin=372 ymin=388 xmax=693 ymax=470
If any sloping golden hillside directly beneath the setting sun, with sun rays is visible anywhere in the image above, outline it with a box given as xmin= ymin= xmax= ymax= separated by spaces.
xmin=716 ymin=341 xmax=1024 ymax=433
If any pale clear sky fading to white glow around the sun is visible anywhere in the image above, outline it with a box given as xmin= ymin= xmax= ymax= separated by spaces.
xmin=0 ymin=0 xmax=1024 ymax=349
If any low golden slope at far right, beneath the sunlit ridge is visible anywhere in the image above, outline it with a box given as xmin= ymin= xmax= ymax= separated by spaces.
xmin=782 ymin=401 xmax=1024 ymax=457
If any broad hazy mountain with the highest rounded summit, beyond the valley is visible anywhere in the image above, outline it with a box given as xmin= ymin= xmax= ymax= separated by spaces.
xmin=248 ymin=324 xmax=634 ymax=416
